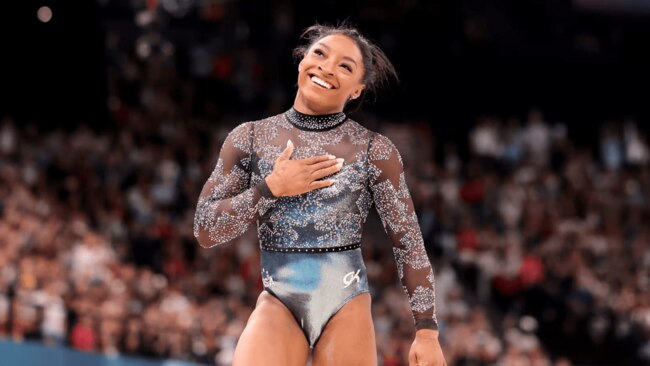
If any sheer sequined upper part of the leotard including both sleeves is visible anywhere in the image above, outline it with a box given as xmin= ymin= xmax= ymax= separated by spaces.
xmin=194 ymin=109 xmax=435 ymax=325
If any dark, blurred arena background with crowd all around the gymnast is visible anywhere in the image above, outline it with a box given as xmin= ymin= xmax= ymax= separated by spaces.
xmin=0 ymin=0 xmax=650 ymax=366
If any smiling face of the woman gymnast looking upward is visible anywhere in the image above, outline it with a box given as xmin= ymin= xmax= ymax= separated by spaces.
xmin=294 ymin=34 xmax=365 ymax=114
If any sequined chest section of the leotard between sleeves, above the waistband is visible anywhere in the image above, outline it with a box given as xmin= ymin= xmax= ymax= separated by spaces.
xmin=244 ymin=114 xmax=373 ymax=248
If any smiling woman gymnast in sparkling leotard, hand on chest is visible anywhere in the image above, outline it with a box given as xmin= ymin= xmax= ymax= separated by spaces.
xmin=194 ymin=25 xmax=445 ymax=366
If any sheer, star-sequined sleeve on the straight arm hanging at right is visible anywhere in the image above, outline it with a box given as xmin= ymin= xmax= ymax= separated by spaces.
xmin=368 ymin=134 xmax=438 ymax=329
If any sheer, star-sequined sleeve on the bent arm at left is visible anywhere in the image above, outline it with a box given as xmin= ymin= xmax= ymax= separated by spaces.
xmin=194 ymin=122 xmax=276 ymax=248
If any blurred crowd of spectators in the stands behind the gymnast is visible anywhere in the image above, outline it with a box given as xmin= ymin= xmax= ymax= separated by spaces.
xmin=0 ymin=3 xmax=650 ymax=366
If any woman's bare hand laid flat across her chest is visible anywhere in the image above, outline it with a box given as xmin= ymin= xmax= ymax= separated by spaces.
xmin=265 ymin=140 xmax=343 ymax=197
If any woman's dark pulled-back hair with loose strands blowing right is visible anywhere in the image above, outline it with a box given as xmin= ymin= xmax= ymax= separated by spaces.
xmin=293 ymin=22 xmax=399 ymax=109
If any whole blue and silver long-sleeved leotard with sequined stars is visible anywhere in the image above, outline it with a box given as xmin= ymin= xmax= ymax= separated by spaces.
xmin=194 ymin=109 xmax=437 ymax=347
